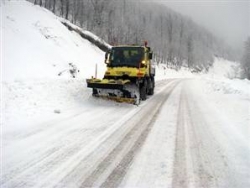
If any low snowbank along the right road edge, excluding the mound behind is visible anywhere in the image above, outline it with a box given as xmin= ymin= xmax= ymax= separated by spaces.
xmin=196 ymin=76 xmax=250 ymax=141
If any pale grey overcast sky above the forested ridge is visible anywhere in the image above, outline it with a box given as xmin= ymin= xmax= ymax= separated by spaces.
xmin=152 ymin=0 xmax=250 ymax=48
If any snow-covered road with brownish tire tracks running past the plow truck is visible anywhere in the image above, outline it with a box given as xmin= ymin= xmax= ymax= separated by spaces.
xmin=1 ymin=79 xmax=250 ymax=187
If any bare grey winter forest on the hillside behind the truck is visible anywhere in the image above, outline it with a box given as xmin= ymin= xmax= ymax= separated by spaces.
xmin=30 ymin=0 xmax=236 ymax=72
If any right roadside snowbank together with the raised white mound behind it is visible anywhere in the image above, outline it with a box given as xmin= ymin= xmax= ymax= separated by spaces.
xmin=201 ymin=58 xmax=250 ymax=139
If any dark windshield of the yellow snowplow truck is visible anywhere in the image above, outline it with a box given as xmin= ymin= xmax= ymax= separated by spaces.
xmin=110 ymin=47 xmax=144 ymax=67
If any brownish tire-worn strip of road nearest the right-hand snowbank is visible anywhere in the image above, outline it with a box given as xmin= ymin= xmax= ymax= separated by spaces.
xmin=172 ymin=83 xmax=227 ymax=188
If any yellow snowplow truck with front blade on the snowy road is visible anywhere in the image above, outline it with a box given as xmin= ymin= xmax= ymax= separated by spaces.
xmin=86 ymin=43 xmax=155 ymax=105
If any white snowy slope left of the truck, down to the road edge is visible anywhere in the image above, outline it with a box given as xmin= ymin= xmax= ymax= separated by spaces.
xmin=1 ymin=1 xmax=105 ymax=128
